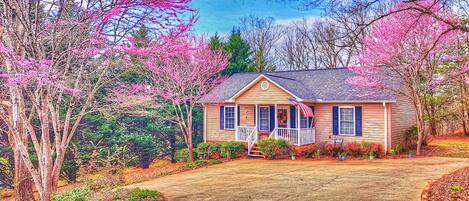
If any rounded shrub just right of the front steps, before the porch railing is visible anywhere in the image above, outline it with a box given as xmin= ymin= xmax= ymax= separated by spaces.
xmin=259 ymin=138 xmax=291 ymax=159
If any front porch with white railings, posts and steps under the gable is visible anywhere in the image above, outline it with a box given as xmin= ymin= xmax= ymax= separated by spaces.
xmin=231 ymin=104 xmax=316 ymax=153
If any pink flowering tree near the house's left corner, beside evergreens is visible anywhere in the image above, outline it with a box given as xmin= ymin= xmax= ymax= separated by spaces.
xmin=115 ymin=36 xmax=229 ymax=160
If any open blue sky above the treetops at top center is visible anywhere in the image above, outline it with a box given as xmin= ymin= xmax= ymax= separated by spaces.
xmin=191 ymin=0 xmax=320 ymax=35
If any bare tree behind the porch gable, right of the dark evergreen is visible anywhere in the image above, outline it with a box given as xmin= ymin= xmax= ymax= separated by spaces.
xmin=241 ymin=15 xmax=285 ymax=72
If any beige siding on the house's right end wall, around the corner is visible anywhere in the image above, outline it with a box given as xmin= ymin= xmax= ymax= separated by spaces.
xmin=390 ymin=95 xmax=416 ymax=147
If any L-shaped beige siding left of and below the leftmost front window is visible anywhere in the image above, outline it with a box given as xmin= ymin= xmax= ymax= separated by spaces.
xmin=205 ymin=104 xmax=235 ymax=142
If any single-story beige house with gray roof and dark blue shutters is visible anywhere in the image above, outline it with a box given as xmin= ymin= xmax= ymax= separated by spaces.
xmin=201 ymin=68 xmax=415 ymax=153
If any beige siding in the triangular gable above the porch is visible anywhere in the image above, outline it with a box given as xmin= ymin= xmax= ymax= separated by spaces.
xmin=235 ymin=79 xmax=292 ymax=104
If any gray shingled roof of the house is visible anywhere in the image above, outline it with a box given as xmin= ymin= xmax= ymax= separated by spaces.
xmin=201 ymin=68 xmax=399 ymax=102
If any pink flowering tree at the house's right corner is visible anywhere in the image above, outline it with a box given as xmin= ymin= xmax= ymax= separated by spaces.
xmin=348 ymin=2 xmax=469 ymax=154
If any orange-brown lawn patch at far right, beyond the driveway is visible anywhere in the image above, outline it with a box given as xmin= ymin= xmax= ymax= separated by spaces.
xmin=428 ymin=137 xmax=469 ymax=158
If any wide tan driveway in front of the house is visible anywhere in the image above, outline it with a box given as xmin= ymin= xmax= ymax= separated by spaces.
xmin=128 ymin=157 xmax=469 ymax=200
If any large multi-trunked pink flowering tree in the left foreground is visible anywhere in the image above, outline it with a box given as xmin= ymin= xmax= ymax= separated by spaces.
xmin=0 ymin=0 xmax=195 ymax=200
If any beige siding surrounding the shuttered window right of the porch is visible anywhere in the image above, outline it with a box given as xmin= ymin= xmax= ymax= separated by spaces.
xmin=314 ymin=103 xmax=384 ymax=144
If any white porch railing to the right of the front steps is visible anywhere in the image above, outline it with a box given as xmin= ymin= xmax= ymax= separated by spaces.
xmin=273 ymin=128 xmax=315 ymax=146
